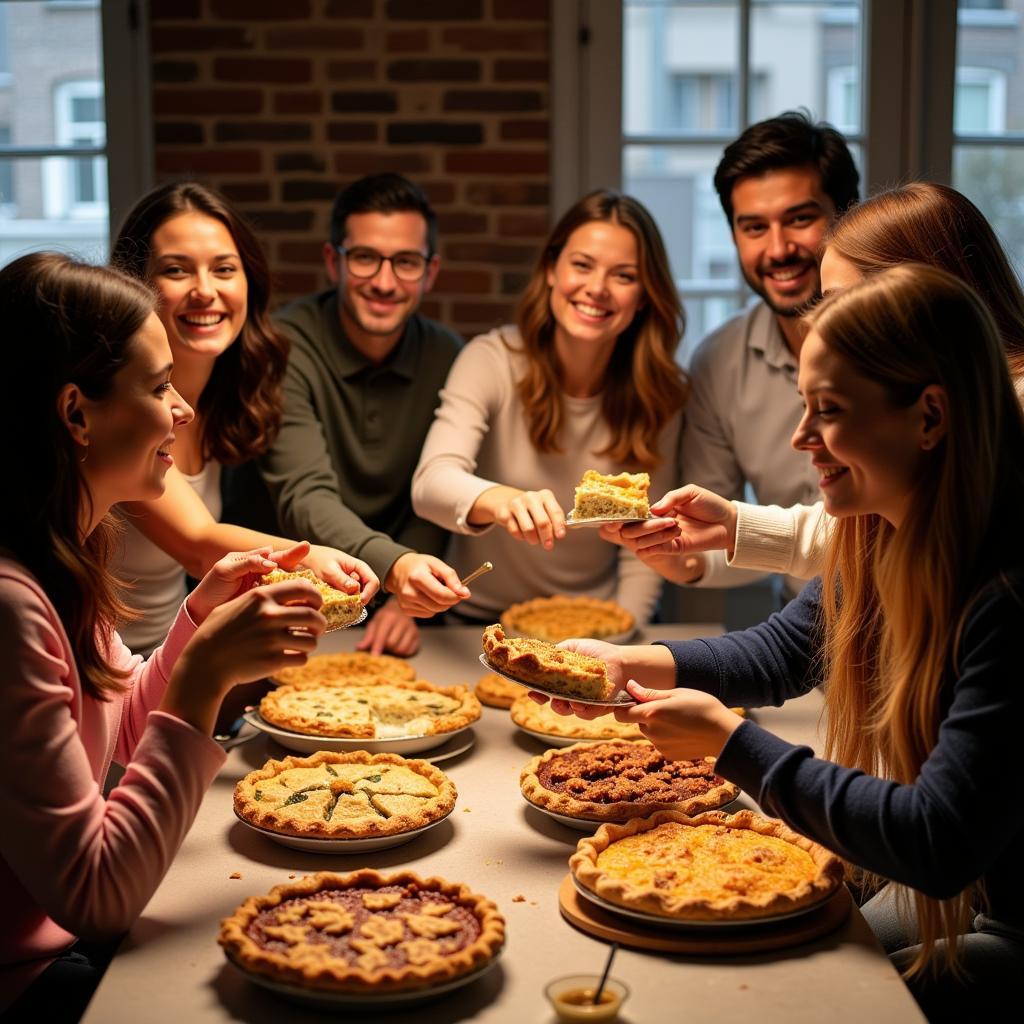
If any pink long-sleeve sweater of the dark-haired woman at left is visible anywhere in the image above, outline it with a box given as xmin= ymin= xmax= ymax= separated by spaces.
xmin=0 ymin=558 xmax=225 ymax=1011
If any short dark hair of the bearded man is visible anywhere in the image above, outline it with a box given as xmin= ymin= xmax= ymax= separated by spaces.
xmin=715 ymin=111 xmax=860 ymax=224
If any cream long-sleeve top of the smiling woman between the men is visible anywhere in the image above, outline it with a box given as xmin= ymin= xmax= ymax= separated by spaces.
xmin=413 ymin=327 xmax=682 ymax=623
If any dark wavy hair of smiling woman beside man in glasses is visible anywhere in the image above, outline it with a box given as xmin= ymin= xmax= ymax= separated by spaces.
xmin=111 ymin=181 xmax=289 ymax=465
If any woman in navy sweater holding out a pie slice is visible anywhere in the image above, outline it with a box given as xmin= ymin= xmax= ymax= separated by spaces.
xmin=548 ymin=264 xmax=1024 ymax=1019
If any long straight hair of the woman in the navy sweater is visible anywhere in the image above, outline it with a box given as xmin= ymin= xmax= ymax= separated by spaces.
xmin=809 ymin=263 xmax=1024 ymax=974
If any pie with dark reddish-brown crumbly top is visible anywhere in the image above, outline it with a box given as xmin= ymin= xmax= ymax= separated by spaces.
xmin=519 ymin=739 xmax=739 ymax=821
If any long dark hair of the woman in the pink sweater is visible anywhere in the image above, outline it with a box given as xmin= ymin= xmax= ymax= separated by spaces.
xmin=0 ymin=253 xmax=157 ymax=699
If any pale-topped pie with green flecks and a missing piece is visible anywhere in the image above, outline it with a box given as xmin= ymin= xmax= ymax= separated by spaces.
xmin=259 ymin=679 xmax=480 ymax=739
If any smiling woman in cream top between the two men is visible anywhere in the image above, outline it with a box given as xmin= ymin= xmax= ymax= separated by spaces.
xmin=413 ymin=190 xmax=686 ymax=622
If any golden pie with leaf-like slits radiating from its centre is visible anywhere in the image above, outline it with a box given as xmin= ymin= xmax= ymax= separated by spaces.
xmin=234 ymin=751 xmax=456 ymax=839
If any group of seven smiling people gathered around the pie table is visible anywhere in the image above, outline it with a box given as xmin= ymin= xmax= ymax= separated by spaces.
xmin=0 ymin=108 xmax=1024 ymax=1020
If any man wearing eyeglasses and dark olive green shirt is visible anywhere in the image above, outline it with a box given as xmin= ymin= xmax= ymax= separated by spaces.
xmin=261 ymin=174 xmax=469 ymax=654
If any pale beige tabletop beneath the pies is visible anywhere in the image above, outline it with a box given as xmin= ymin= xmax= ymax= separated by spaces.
xmin=84 ymin=626 xmax=923 ymax=1024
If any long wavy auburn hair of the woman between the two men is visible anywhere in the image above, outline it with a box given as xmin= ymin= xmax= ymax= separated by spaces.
xmin=516 ymin=189 xmax=689 ymax=469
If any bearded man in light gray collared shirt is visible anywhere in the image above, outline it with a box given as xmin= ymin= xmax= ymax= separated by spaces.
xmin=675 ymin=113 xmax=859 ymax=592
